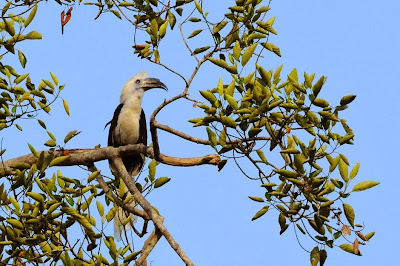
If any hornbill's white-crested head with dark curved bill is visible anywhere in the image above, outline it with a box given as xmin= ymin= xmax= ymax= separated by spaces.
xmin=120 ymin=71 xmax=168 ymax=103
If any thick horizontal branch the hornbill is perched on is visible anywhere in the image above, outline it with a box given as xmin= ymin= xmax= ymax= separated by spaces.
xmin=0 ymin=144 xmax=220 ymax=177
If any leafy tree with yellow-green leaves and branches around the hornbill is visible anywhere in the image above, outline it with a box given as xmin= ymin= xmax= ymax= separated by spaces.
xmin=0 ymin=0 xmax=378 ymax=265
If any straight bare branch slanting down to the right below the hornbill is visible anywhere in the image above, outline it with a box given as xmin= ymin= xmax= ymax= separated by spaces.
xmin=111 ymin=157 xmax=194 ymax=265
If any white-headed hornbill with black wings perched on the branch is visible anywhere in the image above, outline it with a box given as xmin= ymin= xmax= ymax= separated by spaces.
xmin=107 ymin=71 xmax=168 ymax=240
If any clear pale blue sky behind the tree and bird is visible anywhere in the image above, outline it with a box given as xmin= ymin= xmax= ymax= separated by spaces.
xmin=0 ymin=0 xmax=400 ymax=266
